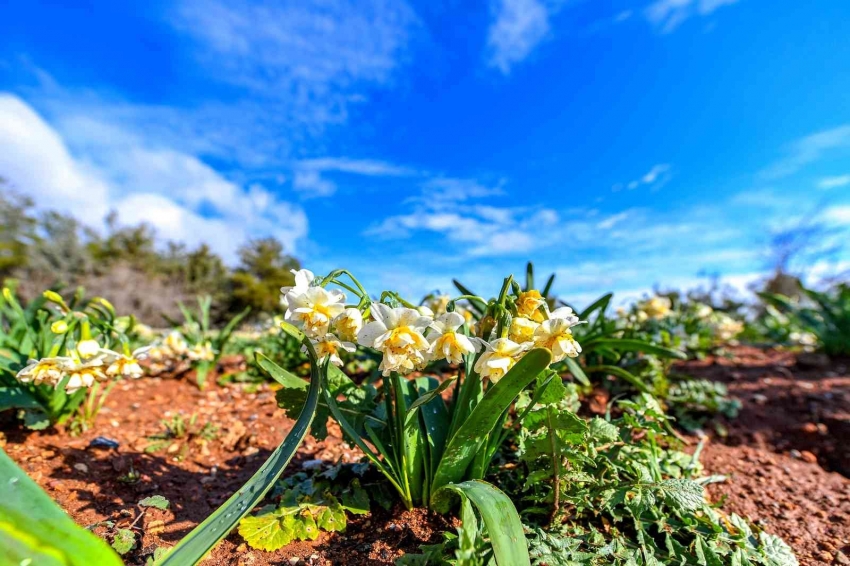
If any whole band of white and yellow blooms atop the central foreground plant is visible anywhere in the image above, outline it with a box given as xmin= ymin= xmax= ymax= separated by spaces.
xmin=281 ymin=269 xmax=581 ymax=382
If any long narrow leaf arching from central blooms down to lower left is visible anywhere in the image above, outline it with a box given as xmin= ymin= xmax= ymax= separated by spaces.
xmin=158 ymin=359 xmax=328 ymax=566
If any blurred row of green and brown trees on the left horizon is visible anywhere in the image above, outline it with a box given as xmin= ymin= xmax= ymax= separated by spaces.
xmin=0 ymin=186 xmax=300 ymax=326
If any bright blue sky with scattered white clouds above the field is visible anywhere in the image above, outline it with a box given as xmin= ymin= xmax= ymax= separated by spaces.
xmin=0 ymin=0 xmax=850 ymax=304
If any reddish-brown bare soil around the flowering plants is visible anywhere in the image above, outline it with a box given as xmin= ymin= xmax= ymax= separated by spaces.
xmin=0 ymin=347 xmax=850 ymax=566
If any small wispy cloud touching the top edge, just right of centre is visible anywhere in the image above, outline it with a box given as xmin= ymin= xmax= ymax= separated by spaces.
xmin=487 ymin=0 xmax=549 ymax=75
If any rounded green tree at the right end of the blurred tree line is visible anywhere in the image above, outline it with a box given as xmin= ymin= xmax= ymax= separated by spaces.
xmin=231 ymin=237 xmax=300 ymax=313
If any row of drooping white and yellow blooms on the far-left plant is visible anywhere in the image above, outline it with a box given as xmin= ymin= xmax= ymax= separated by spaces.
xmin=17 ymin=340 xmax=147 ymax=394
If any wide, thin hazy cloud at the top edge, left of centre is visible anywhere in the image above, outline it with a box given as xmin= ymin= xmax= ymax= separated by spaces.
xmin=171 ymin=0 xmax=417 ymax=98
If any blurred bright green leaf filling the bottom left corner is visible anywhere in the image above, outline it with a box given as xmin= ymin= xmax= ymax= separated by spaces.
xmin=0 ymin=450 xmax=122 ymax=566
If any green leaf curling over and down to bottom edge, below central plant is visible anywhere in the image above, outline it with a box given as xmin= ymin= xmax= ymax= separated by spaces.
xmin=434 ymin=484 xmax=531 ymax=566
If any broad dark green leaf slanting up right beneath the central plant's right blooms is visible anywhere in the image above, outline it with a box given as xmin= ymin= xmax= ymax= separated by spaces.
xmin=431 ymin=348 xmax=552 ymax=506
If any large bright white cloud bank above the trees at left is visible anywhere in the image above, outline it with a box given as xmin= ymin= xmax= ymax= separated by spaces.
xmin=0 ymin=95 xmax=307 ymax=261
